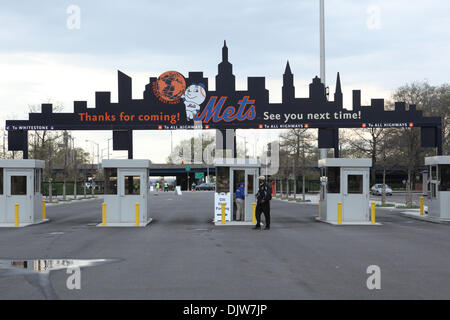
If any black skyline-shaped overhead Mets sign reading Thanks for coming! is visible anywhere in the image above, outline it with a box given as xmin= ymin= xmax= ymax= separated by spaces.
xmin=6 ymin=43 xmax=442 ymax=158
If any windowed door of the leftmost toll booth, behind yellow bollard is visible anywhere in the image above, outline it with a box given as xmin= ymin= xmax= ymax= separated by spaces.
xmin=5 ymin=170 xmax=33 ymax=223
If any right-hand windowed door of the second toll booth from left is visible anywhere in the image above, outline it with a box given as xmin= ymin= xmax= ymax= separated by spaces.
xmin=119 ymin=170 xmax=147 ymax=222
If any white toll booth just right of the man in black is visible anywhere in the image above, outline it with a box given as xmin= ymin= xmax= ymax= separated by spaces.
xmin=318 ymin=158 xmax=372 ymax=224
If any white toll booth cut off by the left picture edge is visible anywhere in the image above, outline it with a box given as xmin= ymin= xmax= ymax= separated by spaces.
xmin=0 ymin=159 xmax=48 ymax=227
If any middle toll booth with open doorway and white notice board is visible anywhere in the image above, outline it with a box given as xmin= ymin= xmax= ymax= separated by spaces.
xmin=213 ymin=158 xmax=261 ymax=225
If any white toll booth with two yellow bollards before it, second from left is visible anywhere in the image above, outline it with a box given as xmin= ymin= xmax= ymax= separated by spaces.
xmin=99 ymin=159 xmax=152 ymax=227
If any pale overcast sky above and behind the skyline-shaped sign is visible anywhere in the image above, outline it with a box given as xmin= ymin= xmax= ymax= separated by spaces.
xmin=0 ymin=0 xmax=450 ymax=162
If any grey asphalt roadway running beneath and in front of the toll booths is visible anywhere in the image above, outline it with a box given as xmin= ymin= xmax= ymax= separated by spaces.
xmin=0 ymin=192 xmax=450 ymax=299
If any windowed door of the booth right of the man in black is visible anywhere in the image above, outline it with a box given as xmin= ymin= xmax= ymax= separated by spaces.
xmin=341 ymin=170 xmax=369 ymax=221
